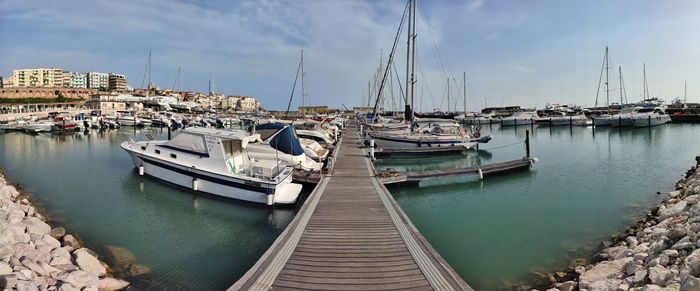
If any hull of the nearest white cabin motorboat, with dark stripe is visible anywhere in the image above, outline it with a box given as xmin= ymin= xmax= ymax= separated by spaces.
xmin=122 ymin=146 xmax=302 ymax=204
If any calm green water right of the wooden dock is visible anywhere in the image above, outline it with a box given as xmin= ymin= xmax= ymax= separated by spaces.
xmin=377 ymin=124 xmax=700 ymax=290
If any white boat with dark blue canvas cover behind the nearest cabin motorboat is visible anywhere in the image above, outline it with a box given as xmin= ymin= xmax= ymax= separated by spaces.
xmin=248 ymin=123 xmax=323 ymax=171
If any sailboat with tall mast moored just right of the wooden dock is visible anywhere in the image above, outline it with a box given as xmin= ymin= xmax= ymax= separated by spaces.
xmin=369 ymin=0 xmax=477 ymax=149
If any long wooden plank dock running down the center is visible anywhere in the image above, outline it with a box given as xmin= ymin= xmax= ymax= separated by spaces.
xmin=229 ymin=125 xmax=472 ymax=290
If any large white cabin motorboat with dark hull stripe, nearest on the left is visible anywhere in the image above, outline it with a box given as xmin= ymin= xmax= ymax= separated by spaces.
xmin=121 ymin=128 xmax=302 ymax=205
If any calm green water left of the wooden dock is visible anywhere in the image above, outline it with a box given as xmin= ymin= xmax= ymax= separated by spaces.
xmin=0 ymin=129 xmax=295 ymax=290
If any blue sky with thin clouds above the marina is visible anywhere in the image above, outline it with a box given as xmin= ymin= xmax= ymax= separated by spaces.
xmin=0 ymin=0 xmax=700 ymax=111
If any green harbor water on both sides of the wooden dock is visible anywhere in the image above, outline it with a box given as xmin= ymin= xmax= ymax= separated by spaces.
xmin=0 ymin=124 xmax=700 ymax=290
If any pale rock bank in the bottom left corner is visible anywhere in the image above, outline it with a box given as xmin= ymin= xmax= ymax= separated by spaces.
xmin=0 ymin=175 xmax=129 ymax=290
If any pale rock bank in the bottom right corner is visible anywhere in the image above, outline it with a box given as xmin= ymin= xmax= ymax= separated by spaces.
xmin=548 ymin=156 xmax=700 ymax=291
